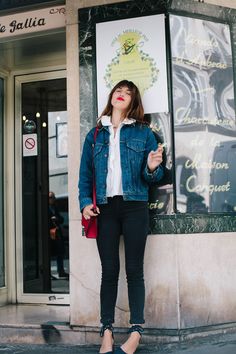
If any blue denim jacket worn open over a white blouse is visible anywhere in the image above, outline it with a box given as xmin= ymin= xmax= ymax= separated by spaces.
xmin=79 ymin=122 xmax=163 ymax=210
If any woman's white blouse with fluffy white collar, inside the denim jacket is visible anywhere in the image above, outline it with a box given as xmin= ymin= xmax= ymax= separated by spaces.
xmin=101 ymin=116 xmax=135 ymax=197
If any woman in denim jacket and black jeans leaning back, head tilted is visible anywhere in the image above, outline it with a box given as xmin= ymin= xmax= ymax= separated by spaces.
xmin=79 ymin=80 xmax=163 ymax=354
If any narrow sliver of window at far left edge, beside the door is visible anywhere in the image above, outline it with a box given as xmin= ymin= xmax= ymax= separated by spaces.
xmin=0 ymin=79 xmax=5 ymax=287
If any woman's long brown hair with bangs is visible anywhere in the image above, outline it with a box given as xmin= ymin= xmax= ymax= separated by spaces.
xmin=101 ymin=80 xmax=148 ymax=124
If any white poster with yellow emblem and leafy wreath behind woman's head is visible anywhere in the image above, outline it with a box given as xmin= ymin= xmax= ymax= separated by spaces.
xmin=96 ymin=15 xmax=169 ymax=114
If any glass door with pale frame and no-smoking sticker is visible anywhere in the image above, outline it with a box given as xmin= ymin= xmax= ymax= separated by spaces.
xmin=16 ymin=71 xmax=69 ymax=304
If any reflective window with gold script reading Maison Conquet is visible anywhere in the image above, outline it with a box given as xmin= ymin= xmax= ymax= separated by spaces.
xmin=170 ymin=16 xmax=236 ymax=213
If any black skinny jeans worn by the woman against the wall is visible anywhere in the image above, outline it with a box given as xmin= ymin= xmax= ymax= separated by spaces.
xmin=97 ymin=196 xmax=148 ymax=325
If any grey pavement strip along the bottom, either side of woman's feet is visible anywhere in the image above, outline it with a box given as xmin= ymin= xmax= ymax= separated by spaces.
xmin=0 ymin=334 xmax=236 ymax=354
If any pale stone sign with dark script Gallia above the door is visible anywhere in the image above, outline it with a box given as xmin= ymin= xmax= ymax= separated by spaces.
xmin=0 ymin=6 xmax=65 ymax=41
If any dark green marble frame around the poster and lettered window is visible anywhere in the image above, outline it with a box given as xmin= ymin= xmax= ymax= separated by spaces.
xmin=79 ymin=0 xmax=236 ymax=234
